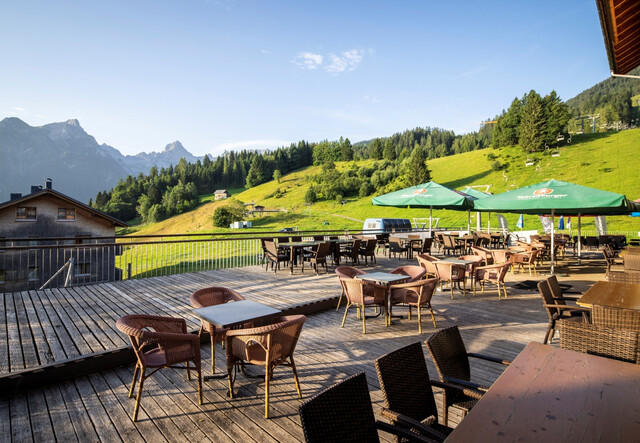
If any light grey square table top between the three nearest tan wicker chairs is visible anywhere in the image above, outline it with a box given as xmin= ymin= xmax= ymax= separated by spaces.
xmin=193 ymin=300 xmax=281 ymax=328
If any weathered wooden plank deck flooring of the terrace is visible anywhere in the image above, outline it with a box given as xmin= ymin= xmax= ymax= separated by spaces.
xmin=0 ymin=253 xmax=604 ymax=441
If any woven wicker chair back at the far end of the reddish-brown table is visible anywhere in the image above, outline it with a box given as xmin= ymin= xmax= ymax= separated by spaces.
xmin=558 ymin=319 xmax=640 ymax=364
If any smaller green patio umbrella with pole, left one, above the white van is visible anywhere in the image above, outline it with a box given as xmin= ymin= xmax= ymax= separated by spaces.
xmin=371 ymin=181 xmax=473 ymax=232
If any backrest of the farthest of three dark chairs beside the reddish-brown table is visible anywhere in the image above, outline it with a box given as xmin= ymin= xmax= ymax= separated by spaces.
xmin=425 ymin=325 xmax=471 ymax=381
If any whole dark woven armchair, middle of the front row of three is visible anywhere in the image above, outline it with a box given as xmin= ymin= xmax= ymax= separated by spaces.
xmin=374 ymin=342 xmax=464 ymax=440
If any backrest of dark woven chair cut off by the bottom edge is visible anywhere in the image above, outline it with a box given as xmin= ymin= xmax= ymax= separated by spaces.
xmin=298 ymin=372 xmax=379 ymax=443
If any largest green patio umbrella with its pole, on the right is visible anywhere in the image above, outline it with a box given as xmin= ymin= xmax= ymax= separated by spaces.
xmin=473 ymin=180 xmax=640 ymax=274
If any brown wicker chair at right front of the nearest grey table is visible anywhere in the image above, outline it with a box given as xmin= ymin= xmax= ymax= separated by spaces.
xmin=225 ymin=315 xmax=307 ymax=418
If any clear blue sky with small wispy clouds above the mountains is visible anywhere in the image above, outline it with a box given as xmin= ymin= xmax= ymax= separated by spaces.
xmin=0 ymin=0 xmax=609 ymax=155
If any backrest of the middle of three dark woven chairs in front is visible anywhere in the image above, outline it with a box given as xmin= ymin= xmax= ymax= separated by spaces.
xmin=374 ymin=342 xmax=438 ymax=423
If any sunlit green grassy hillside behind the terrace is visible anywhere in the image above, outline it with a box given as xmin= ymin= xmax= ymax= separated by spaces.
xmin=127 ymin=129 xmax=640 ymax=238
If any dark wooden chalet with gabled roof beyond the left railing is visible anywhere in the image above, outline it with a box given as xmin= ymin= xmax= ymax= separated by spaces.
xmin=0 ymin=179 xmax=128 ymax=292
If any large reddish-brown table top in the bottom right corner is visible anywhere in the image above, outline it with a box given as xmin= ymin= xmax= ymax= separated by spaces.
xmin=446 ymin=342 xmax=640 ymax=442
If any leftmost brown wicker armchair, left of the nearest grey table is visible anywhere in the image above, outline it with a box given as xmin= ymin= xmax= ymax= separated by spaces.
xmin=116 ymin=315 xmax=202 ymax=421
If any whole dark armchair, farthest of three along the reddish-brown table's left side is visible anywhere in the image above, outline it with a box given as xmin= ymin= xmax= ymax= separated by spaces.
xmin=425 ymin=326 xmax=511 ymax=423
